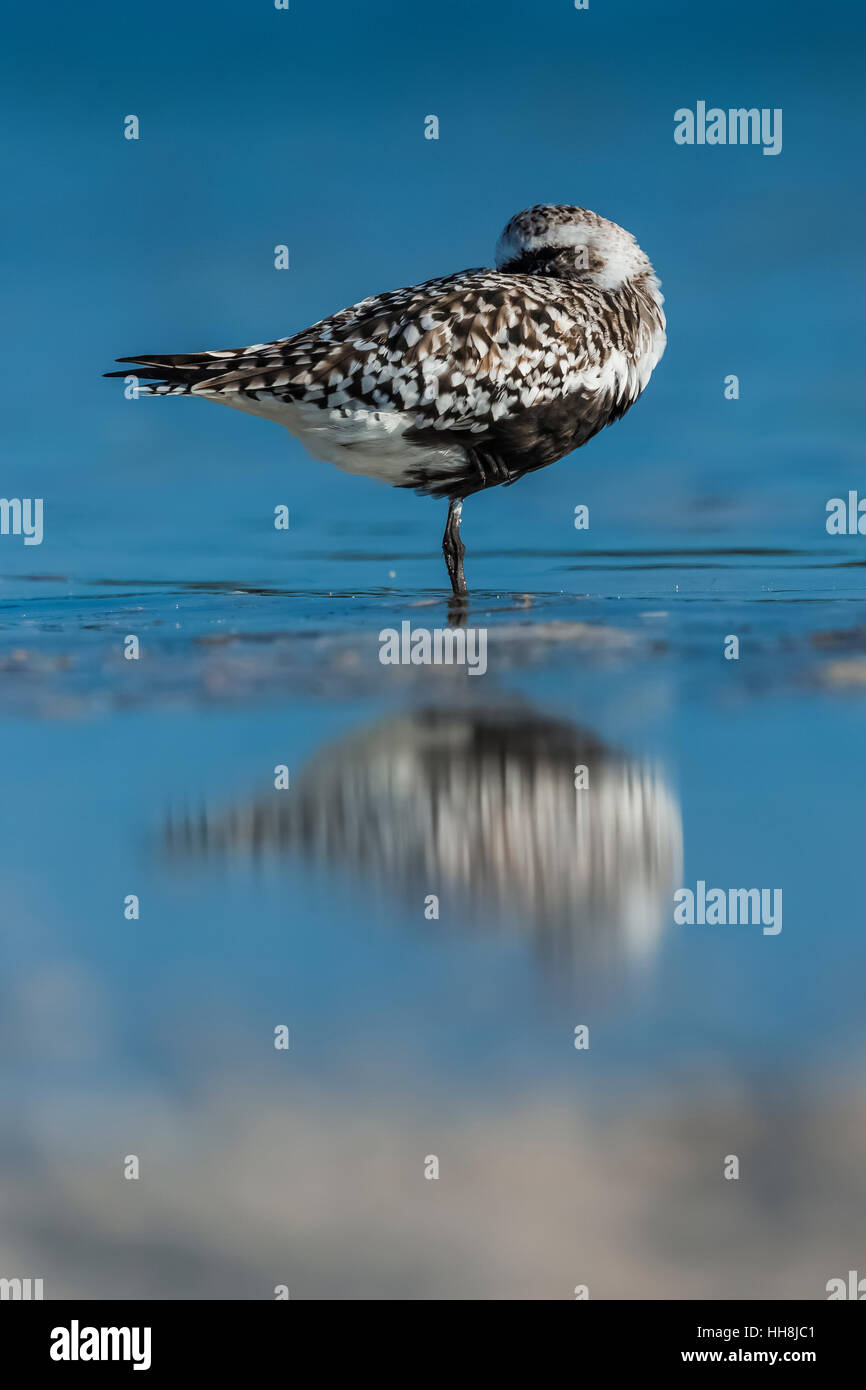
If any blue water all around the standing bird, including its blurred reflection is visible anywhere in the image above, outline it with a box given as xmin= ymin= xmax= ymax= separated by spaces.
xmin=0 ymin=0 xmax=866 ymax=1298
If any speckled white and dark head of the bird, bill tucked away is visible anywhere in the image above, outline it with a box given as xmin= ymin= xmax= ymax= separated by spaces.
xmin=496 ymin=204 xmax=657 ymax=289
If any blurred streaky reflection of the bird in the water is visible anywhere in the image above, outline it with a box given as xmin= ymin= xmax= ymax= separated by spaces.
xmin=165 ymin=706 xmax=683 ymax=959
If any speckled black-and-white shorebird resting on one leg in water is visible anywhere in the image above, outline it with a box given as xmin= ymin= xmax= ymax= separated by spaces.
xmin=106 ymin=203 xmax=666 ymax=602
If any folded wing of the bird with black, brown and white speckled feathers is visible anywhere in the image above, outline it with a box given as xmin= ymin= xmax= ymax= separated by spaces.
xmin=107 ymin=270 xmax=607 ymax=432
